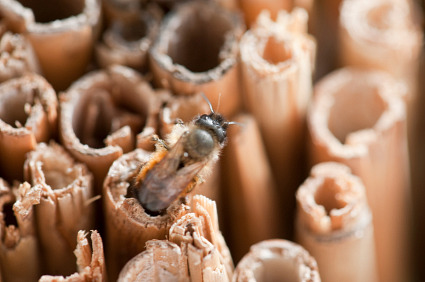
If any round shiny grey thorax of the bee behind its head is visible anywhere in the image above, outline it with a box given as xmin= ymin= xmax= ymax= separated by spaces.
xmin=185 ymin=129 xmax=214 ymax=159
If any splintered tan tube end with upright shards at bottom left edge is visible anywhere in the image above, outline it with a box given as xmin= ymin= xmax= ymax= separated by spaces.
xmin=39 ymin=230 xmax=107 ymax=282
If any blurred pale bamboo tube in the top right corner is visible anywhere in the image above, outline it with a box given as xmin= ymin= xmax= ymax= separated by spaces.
xmin=339 ymin=0 xmax=423 ymax=103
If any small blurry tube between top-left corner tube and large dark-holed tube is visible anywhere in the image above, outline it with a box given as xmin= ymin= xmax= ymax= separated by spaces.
xmin=95 ymin=6 xmax=162 ymax=71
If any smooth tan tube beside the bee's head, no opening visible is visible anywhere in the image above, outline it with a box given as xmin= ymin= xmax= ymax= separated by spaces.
xmin=222 ymin=114 xmax=281 ymax=261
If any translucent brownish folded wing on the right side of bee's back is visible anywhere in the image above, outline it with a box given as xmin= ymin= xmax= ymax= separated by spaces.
xmin=138 ymin=162 xmax=206 ymax=212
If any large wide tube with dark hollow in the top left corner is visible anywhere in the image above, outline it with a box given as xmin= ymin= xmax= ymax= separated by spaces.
xmin=0 ymin=0 xmax=100 ymax=90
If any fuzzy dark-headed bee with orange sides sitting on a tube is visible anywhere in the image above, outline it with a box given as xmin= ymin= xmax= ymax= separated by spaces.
xmin=130 ymin=96 xmax=233 ymax=215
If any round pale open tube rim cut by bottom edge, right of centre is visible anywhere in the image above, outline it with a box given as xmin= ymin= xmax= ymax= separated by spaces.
xmin=232 ymin=239 xmax=320 ymax=282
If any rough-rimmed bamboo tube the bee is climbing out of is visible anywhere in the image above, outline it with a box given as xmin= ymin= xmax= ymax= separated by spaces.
xmin=103 ymin=149 xmax=189 ymax=280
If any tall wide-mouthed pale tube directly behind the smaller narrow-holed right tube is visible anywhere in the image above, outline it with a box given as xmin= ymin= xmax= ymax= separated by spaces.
xmin=308 ymin=68 xmax=411 ymax=281
